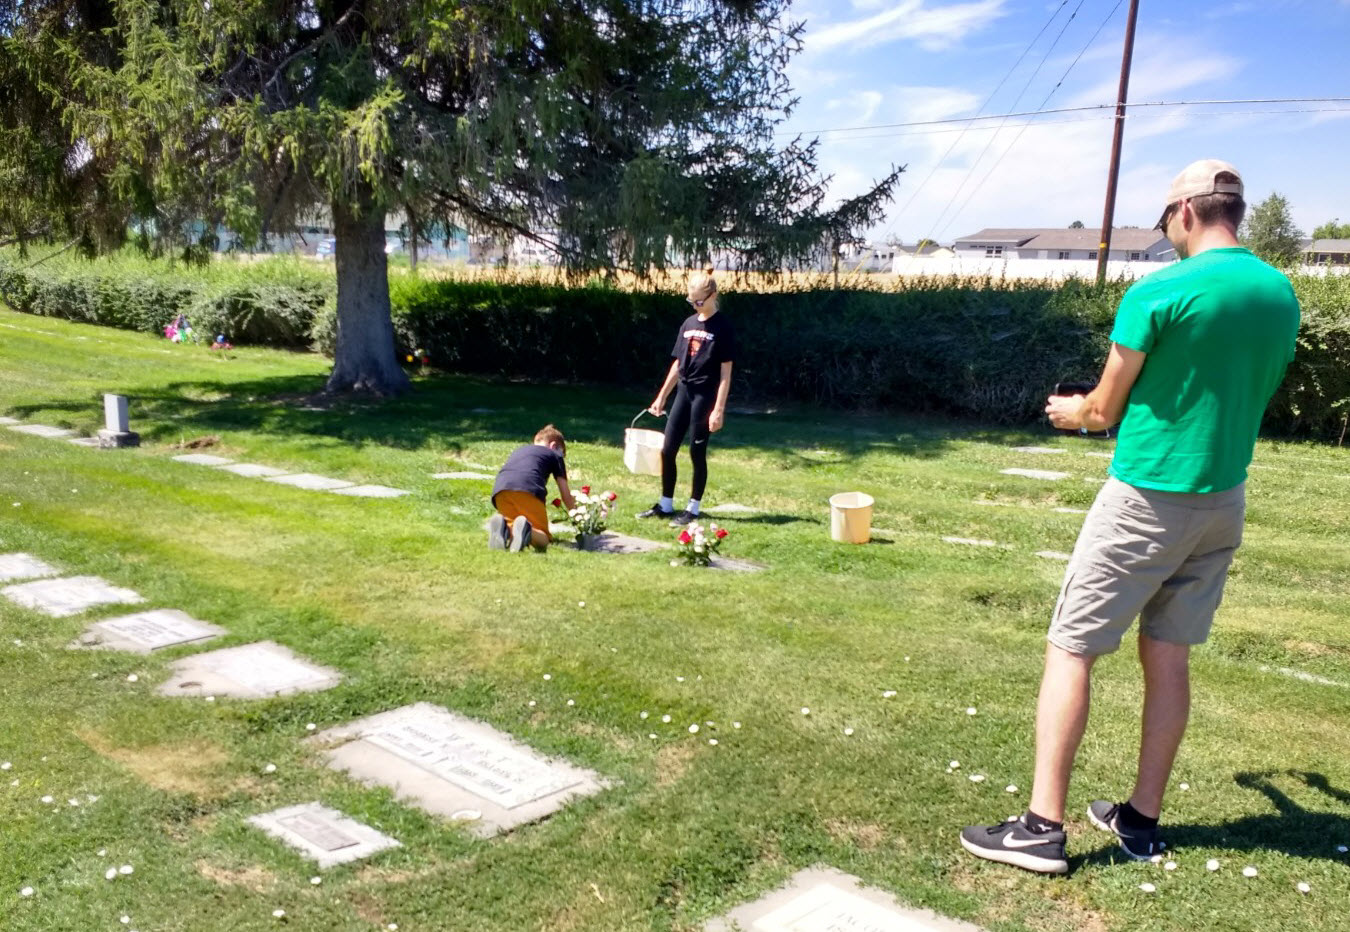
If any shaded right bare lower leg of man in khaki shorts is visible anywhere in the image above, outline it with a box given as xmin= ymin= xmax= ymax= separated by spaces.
xmin=1130 ymin=635 xmax=1191 ymax=819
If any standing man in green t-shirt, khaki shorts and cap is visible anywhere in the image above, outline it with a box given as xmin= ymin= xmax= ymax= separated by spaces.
xmin=961 ymin=159 xmax=1299 ymax=874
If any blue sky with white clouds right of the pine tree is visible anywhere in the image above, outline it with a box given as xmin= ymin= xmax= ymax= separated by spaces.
xmin=783 ymin=0 xmax=1350 ymax=243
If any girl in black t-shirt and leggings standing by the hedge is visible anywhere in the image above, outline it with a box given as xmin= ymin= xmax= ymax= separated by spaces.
xmin=639 ymin=269 xmax=736 ymax=527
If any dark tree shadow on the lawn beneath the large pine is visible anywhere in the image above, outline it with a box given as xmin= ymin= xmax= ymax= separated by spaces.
xmin=15 ymin=374 xmax=972 ymax=465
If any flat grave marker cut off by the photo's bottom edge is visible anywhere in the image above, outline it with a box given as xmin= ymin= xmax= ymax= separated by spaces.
xmin=703 ymin=867 xmax=981 ymax=932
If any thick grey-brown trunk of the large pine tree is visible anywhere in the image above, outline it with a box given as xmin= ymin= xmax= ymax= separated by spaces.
xmin=325 ymin=188 xmax=410 ymax=396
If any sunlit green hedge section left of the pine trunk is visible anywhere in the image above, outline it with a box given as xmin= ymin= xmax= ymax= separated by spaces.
xmin=0 ymin=251 xmax=333 ymax=348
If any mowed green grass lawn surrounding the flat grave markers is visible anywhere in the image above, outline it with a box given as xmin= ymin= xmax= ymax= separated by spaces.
xmin=0 ymin=311 xmax=1350 ymax=932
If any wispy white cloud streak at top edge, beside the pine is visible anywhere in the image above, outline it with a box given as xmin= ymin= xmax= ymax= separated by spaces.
xmin=805 ymin=0 xmax=1004 ymax=53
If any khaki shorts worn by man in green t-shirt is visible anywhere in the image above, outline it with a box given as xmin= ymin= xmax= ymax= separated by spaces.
xmin=1049 ymin=480 xmax=1246 ymax=656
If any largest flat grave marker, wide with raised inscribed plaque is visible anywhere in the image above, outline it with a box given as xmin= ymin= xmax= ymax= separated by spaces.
xmin=311 ymin=702 xmax=609 ymax=837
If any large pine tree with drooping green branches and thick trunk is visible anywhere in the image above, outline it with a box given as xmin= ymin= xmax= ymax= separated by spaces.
xmin=0 ymin=0 xmax=899 ymax=394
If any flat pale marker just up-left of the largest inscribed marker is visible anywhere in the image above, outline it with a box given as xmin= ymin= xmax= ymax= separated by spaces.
xmin=159 ymin=640 xmax=342 ymax=698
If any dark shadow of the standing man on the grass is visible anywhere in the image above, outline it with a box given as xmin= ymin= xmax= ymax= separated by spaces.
xmin=1080 ymin=770 xmax=1350 ymax=863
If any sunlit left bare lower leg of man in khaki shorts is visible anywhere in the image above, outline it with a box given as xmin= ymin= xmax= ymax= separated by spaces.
xmin=1030 ymin=643 xmax=1096 ymax=823
